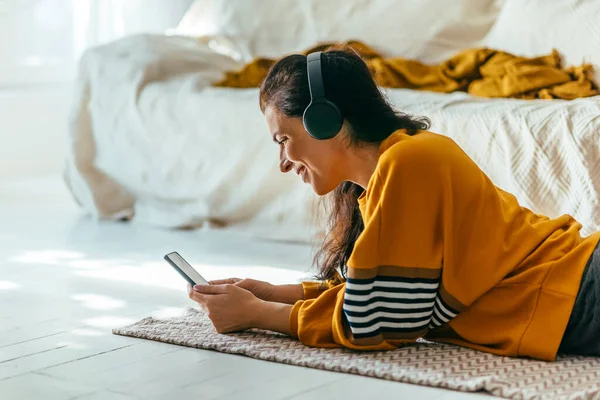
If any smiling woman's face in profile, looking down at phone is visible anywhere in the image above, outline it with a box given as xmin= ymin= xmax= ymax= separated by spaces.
xmin=265 ymin=106 xmax=347 ymax=196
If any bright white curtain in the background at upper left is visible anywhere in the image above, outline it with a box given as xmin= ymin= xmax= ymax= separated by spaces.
xmin=0 ymin=0 xmax=193 ymax=86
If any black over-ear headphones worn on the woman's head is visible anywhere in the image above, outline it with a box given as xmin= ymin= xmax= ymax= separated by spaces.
xmin=302 ymin=51 xmax=344 ymax=140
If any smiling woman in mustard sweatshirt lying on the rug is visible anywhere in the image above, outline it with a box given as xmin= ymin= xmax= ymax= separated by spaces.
xmin=189 ymin=51 xmax=600 ymax=360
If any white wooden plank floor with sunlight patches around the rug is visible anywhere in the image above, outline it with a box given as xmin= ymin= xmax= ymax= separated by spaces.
xmin=0 ymin=177 xmax=490 ymax=400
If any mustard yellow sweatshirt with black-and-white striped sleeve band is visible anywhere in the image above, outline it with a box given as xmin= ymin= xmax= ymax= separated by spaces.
xmin=290 ymin=130 xmax=600 ymax=360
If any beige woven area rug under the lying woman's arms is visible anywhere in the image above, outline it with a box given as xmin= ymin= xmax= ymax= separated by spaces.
xmin=113 ymin=308 xmax=600 ymax=399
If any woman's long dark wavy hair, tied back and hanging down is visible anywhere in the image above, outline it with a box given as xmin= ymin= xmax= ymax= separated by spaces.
xmin=260 ymin=50 xmax=430 ymax=280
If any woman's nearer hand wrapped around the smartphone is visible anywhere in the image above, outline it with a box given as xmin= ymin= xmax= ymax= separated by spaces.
xmin=188 ymin=284 xmax=261 ymax=333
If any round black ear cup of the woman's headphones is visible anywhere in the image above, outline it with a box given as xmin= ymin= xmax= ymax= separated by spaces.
xmin=302 ymin=99 xmax=344 ymax=140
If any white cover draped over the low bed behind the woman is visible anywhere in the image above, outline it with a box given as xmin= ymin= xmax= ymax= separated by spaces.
xmin=65 ymin=36 xmax=600 ymax=241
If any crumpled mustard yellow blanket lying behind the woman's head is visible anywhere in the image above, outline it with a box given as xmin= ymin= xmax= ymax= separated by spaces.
xmin=215 ymin=41 xmax=599 ymax=100
